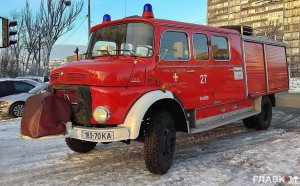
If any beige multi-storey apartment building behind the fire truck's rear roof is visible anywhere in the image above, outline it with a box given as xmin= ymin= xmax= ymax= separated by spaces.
xmin=207 ymin=0 xmax=300 ymax=71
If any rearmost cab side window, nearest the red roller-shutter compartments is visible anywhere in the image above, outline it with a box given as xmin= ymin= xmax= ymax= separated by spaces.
xmin=211 ymin=36 xmax=229 ymax=61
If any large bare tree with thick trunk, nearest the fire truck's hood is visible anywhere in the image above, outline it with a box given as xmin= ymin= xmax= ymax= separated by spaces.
xmin=38 ymin=0 xmax=83 ymax=75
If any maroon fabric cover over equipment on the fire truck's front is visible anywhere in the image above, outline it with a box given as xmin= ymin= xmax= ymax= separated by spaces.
xmin=21 ymin=92 xmax=71 ymax=139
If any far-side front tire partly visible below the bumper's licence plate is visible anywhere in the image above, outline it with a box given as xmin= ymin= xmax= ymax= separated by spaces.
xmin=66 ymin=138 xmax=97 ymax=153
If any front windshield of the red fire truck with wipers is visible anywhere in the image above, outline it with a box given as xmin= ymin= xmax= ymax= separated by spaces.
xmin=87 ymin=23 xmax=153 ymax=58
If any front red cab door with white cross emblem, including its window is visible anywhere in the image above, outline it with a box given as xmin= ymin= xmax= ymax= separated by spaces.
xmin=157 ymin=27 xmax=198 ymax=109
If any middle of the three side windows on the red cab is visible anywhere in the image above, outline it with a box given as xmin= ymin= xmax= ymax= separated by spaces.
xmin=193 ymin=34 xmax=209 ymax=60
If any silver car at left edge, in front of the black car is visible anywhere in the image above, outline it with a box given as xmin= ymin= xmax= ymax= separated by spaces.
xmin=0 ymin=83 xmax=48 ymax=117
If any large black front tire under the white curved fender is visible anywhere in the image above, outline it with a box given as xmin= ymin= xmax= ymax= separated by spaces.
xmin=144 ymin=111 xmax=176 ymax=175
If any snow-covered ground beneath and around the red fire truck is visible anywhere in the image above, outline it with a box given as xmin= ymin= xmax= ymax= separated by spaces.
xmin=0 ymin=108 xmax=300 ymax=186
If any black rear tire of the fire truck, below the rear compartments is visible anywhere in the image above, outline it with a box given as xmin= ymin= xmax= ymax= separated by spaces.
xmin=243 ymin=96 xmax=272 ymax=130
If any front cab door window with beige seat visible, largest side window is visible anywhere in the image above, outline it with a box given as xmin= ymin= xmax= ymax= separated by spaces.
xmin=159 ymin=31 xmax=190 ymax=61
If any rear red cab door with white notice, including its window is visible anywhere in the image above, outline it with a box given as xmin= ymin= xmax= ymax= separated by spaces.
xmin=210 ymin=33 xmax=245 ymax=104
